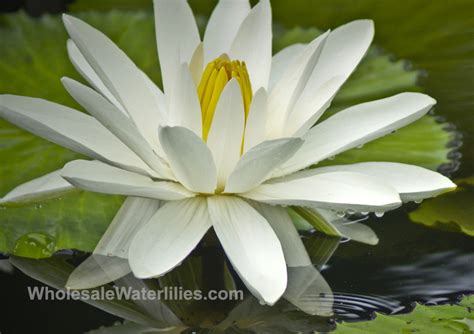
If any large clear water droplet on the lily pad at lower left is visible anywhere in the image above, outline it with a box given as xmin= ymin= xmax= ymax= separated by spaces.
xmin=13 ymin=233 xmax=56 ymax=259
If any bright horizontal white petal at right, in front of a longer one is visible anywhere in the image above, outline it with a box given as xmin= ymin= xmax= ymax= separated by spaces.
xmin=242 ymin=172 xmax=401 ymax=211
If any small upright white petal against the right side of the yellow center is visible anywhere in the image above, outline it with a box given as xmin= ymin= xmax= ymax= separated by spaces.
xmin=244 ymin=88 xmax=268 ymax=152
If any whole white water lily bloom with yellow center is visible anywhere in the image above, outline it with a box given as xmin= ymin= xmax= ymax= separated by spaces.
xmin=0 ymin=0 xmax=455 ymax=304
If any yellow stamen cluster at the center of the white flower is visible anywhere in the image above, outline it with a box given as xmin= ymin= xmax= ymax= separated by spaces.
xmin=198 ymin=55 xmax=252 ymax=140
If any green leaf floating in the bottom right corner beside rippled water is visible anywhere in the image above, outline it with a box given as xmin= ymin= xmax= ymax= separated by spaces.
xmin=334 ymin=296 xmax=474 ymax=334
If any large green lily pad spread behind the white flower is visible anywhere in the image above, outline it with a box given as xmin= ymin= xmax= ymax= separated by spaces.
xmin=0 ymin=11 xmax=451 ymax=258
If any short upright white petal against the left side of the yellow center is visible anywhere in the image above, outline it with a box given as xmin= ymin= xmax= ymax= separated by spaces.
xmin=167 ymin=63 xmax=202 ymax=137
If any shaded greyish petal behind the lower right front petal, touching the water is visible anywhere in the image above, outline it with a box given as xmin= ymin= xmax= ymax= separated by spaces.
xmin=252 ymin=202 xmax=312 ymax=267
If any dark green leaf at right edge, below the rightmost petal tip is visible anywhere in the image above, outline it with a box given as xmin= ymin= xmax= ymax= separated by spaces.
xmin=409 ymin=177 xmax=474 ymax=236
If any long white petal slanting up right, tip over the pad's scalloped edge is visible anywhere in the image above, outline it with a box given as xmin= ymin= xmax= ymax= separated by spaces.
xmin=275 ymin=93 xmax=436 ymax=176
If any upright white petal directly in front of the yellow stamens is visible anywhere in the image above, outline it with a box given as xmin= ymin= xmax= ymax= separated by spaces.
xmin=207 ymin=79 xmax=245 ymax=189
